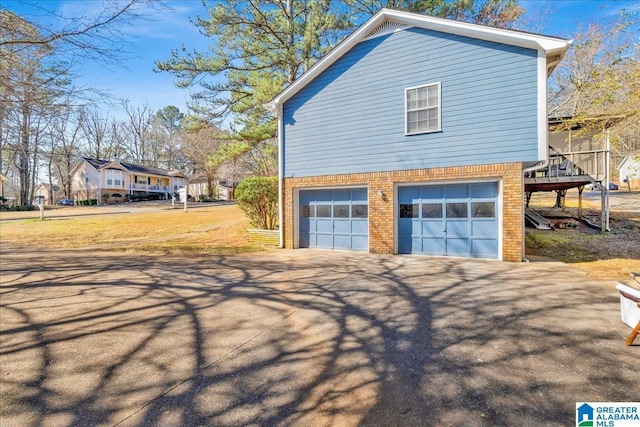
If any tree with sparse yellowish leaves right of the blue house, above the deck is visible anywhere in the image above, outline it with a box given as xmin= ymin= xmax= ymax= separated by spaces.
xmin=549 ymin=20 xmax=640 ymax=156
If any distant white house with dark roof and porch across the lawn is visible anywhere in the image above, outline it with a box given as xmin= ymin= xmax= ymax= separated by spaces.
xmin=71 ymin=157 xmax=187 ymax=203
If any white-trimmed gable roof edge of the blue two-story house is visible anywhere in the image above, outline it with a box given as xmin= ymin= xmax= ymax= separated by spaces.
xmin=265 ymin=9 xmax=573 ymax=113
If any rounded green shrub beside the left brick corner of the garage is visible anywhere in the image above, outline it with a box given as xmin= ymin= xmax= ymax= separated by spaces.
xmin=235 ymin=176 xmax=278 ymax=230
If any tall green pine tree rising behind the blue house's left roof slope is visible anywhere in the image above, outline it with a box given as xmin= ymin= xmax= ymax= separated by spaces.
xmin=156 ymin=0 xmax=524 ymax=168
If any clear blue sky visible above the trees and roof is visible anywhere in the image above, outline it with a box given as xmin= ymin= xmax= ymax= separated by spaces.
xmin=5 ymin=0 xmax=640 ymax=123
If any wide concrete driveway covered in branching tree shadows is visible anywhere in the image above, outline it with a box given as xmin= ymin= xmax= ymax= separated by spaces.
xmin=0 ymin=245 xmax=640 ymax=427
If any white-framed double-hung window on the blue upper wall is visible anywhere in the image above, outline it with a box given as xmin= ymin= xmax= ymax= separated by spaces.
xmin=405 ymin=83 xmax=441 ymax=135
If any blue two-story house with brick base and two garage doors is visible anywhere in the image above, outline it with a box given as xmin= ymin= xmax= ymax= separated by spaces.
xmin=267 ymin=9 xmax=571 ymax=262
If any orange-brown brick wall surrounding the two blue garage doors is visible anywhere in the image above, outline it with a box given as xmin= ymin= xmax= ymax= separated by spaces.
xmin=283 ymin=163 xmax=524 ymax=262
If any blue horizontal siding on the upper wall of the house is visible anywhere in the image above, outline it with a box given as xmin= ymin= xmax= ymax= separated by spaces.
xmin=283 ymin=29 xmax=538 ymax=178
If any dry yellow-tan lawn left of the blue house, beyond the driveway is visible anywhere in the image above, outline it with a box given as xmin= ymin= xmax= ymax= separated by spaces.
xmin=0 ymin=206 xmax=264 ymax=254
